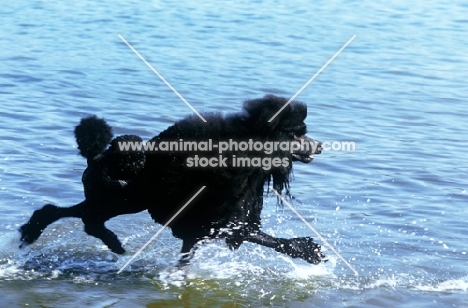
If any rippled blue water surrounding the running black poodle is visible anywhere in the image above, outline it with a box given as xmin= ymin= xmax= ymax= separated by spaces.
xmin=0 ymin=1 xmax=468 ymax=307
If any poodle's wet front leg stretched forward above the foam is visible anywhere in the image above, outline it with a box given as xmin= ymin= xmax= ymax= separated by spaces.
xmin=246 ymin=231 xmax=326 ymax=264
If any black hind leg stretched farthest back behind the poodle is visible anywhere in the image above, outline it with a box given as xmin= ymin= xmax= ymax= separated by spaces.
xmin=19 ymin=201 xmax=86 ymax=247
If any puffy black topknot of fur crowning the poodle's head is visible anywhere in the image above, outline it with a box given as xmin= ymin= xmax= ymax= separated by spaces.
xmin=244 ymin=95 xmax=307 ymax=133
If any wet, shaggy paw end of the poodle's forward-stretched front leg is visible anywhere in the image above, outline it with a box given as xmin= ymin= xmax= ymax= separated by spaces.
xmin=277 ymin=237 xmax=328 ymax=264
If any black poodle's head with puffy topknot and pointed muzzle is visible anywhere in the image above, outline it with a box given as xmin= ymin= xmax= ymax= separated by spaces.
xmin=244 ymin=95 xmax=322 ymax=163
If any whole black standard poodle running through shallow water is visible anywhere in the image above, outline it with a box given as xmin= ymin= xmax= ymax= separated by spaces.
xmin=20 ymin=95 xmax=325 ymax=264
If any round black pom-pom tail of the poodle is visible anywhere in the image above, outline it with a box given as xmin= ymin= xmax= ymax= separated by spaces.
xmin=75 ymin=116 xmax=113 ymax=159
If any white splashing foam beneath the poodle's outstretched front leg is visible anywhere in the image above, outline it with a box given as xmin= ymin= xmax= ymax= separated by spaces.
xmin=157 ymin=243 xmax=336 ymax=286
